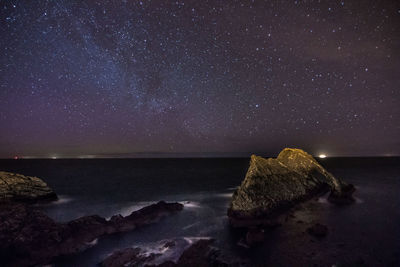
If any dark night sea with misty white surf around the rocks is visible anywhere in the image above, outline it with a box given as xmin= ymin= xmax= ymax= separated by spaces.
xmin=0 ymin=158 xmax=400 ymax=266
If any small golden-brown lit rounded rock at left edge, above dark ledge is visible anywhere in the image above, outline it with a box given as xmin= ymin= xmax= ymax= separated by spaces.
xmin=0 ymin=172 xmax=57 ymax=202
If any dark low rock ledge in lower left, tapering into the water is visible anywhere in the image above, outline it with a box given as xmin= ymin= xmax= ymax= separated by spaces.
xmin=0 ymin=201 xmax=183 ymax=266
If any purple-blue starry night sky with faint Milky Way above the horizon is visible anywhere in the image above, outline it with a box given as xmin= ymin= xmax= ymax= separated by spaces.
xmin=0 ymin=0 xmax=400 ymax=157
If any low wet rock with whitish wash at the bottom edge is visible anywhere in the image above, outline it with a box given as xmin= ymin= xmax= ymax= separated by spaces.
xmin=100 ymin=238 xmax=246 ymax=267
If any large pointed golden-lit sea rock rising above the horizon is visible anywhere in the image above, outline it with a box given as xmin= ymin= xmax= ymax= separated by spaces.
xmin=228 ymin=148 xmax=354 ymax=227
